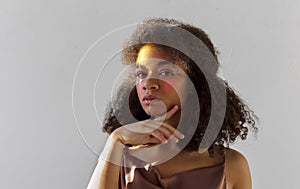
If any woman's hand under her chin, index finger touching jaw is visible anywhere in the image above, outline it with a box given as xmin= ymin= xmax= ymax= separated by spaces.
xmin=111 ymin=105 xmax=184 ymax=146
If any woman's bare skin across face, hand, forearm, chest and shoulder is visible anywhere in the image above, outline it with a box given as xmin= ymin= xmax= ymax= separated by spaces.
xmin=88 ymin=45 xmax=251 ymax=189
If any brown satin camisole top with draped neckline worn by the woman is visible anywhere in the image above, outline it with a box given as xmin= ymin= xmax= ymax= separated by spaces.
xmin=119 ymin=148 xmax=226 ymax=189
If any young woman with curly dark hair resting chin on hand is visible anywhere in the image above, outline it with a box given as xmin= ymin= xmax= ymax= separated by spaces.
xmin=88 ymin=18 xmax=257 ymax=189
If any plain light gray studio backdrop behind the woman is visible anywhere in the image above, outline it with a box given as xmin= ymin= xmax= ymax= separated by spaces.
xmin=0 ymin=0 xmax=300 ymax=189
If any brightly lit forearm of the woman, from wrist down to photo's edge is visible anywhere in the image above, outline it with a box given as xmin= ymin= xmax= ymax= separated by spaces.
xmin=87 ymin=136 xmax=124 ymax=189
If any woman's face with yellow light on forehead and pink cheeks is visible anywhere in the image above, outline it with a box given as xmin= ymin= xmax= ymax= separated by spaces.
xmin=135 ymin=45 xmax=187 ymax=116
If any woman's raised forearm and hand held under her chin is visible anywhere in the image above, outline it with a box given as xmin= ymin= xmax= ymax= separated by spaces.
xmin=87 ymin=106 xmax=184 ymax=189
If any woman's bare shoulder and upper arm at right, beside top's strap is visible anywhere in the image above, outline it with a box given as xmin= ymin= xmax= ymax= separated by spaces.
xmin=225 ymin=149 xmax=252 ymax=189
